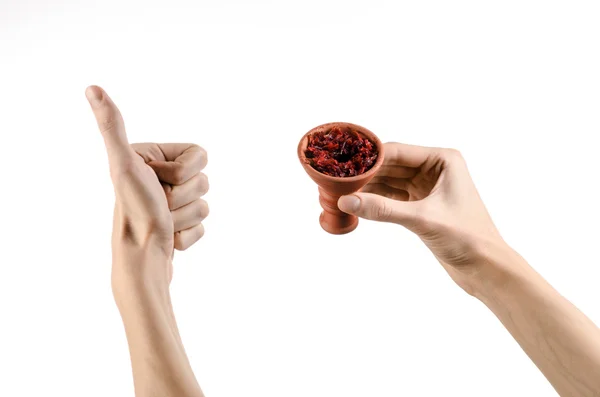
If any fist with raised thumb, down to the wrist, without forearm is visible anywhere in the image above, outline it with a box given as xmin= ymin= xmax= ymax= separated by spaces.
xmin=86 ymin=86 xmax=208 ymax=289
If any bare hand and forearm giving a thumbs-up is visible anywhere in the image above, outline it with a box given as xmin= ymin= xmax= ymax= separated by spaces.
xmin=86 ymin=86 xmax=208 ymax=397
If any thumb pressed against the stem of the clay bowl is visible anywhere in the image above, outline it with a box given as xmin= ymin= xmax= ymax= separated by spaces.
xmin=338 ymin=193 xmax=417 ymax=229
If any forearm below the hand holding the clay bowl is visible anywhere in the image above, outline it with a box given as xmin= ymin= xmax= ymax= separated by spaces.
xmin=475 ymin=243 xmax=600 ymax=396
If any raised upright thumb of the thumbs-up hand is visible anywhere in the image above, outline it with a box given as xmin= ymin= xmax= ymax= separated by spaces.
xmin=85 ymin=85 xmax=132 ymax=166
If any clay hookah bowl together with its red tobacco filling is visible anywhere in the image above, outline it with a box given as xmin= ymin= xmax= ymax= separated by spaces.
xmin=298 ymin=122 xmax=383 ymax=234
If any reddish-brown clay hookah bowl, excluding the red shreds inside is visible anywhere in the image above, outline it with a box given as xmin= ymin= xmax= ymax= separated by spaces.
xmin=298 ymin=122 xmax=383 ymax=234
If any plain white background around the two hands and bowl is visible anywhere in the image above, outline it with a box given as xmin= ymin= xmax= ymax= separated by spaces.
xmin=0 ymin=0 xmax=600 ymax=397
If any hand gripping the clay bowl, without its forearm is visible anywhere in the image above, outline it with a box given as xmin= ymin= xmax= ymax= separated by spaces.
xmin=338 ymin=143 xmax=504 ymax=294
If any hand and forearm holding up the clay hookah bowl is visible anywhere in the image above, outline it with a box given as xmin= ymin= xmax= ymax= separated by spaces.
xmin=338 ymin=143 xmax=600 ymax=397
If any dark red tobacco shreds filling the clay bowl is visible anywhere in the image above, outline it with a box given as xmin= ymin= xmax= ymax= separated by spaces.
xmin=304 ymin=127 xmax=378 ymax=178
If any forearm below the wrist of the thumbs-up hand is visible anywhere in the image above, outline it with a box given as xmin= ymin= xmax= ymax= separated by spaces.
xmin=113 ymin=256 xmax=203 ymax=397
